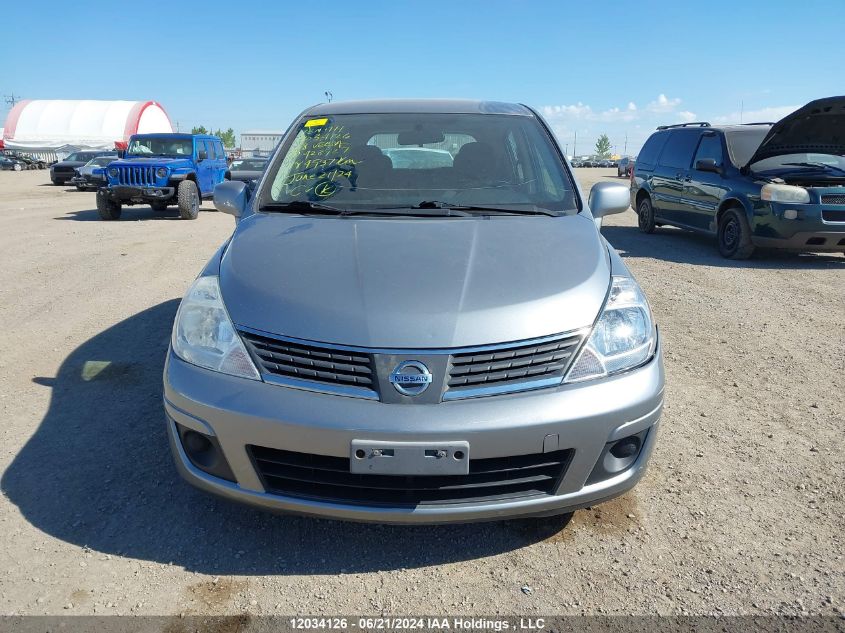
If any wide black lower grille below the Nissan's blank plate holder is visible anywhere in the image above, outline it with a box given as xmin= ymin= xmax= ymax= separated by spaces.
xmin=247 ymin=446 xmax=573 ymax=507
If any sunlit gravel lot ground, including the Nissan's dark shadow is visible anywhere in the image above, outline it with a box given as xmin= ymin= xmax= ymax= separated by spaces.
xmin=0 ymin=169 xmax=845 ymax=615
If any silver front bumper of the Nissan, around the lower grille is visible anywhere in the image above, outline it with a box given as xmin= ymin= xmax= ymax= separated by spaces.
xmin=164 ymin=346 xmax=664 ymax=523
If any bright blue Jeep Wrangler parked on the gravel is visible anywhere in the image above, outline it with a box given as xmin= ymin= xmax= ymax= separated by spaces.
xmin=97 ymin=134 xmax=229 ymax=220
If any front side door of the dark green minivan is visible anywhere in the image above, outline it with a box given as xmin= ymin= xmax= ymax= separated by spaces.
xmin=683 ymin=131 xmax=727 ymax=232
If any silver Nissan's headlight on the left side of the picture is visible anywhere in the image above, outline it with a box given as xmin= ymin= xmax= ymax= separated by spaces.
xmin=172 ymin=277 xmax=261 ymax=380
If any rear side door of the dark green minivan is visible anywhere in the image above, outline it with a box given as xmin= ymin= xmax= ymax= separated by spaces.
xmin=652 ymin=128 xmax=701 ymax=226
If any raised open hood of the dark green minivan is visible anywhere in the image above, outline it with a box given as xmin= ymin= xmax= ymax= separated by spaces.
xmin=746 ymin=96 xmax=845 ymax=167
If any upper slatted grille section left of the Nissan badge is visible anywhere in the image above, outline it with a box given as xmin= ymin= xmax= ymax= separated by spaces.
xmin=240 ymin=331 xmax=375 ymax=390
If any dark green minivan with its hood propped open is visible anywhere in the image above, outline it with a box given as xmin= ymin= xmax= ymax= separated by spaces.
xmin=631 ymin=97 xmax=845 ymax=259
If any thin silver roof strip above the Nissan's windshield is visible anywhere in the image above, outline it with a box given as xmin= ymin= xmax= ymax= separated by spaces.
xmin=303 ymin=99 xmax=534 ymax=116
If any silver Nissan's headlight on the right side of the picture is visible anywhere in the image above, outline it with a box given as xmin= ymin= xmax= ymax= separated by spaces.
xmin=564 ymin=277 xmax=656 ymax=382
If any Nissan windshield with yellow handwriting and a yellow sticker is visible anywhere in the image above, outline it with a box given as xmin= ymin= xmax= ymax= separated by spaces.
xmin=261 ymin=113 xmax=577 ymax=212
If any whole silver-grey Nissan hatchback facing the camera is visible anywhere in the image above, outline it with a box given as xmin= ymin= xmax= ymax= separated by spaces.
xmin=164 ymin=101 xmax=664 ymax=523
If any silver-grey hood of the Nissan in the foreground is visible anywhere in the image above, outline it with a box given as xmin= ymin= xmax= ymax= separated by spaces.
xmin=220 ymin=214 xmax=610 ymax=349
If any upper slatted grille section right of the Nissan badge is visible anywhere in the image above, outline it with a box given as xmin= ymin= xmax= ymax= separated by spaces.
xmin=447 ymin=336 xmax=581 ymax=395
